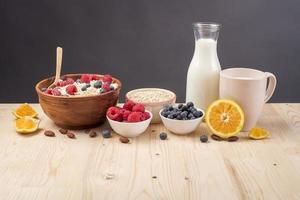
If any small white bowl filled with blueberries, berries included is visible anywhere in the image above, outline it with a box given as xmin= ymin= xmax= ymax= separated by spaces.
xmin=159 ymin=102 xmax=204 ymax=135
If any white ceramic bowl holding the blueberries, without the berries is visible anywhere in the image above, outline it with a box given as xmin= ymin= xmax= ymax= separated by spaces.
xmin=159 ymin=108 xmax=205 ymax=135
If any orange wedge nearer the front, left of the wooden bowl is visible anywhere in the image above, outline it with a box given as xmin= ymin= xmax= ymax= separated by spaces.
xmin=15 ymin=116 xmax=40 ymax=134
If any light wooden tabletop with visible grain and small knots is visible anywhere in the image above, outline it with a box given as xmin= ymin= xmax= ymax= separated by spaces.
xmin=0 ymin=104 xmax=300 ymax=200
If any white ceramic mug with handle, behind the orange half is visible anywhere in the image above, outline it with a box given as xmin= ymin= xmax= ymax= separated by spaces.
xmin=220 ymin=68 xmax=276 ymax=131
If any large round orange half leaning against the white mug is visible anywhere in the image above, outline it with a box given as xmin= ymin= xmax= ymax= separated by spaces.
xmin=205 ymin=99 xmax=245 ymax=138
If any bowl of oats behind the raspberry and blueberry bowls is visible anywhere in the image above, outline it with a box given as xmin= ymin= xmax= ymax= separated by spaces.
xmin=125 ymin=88 xmax=176 ymax=123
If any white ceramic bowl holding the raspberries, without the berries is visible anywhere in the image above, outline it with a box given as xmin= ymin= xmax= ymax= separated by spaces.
xmin=106 ymin=110 xmax=152 ymax=138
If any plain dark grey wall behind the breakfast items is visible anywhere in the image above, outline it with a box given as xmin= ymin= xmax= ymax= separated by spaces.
xmin=0 ymin=0 xmax=300 ymax=102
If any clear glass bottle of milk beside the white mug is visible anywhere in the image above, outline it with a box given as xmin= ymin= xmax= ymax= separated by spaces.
xmin=186 ymin=22 xmax=221 ymax=110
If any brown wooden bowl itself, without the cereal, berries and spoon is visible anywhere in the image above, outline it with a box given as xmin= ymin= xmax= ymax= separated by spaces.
xmin=35 ymin=74 xmax=122 ymax=129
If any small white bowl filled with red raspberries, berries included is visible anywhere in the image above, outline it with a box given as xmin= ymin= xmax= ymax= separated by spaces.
xmin=106 ymin=101 xmax=152 ymax=137
